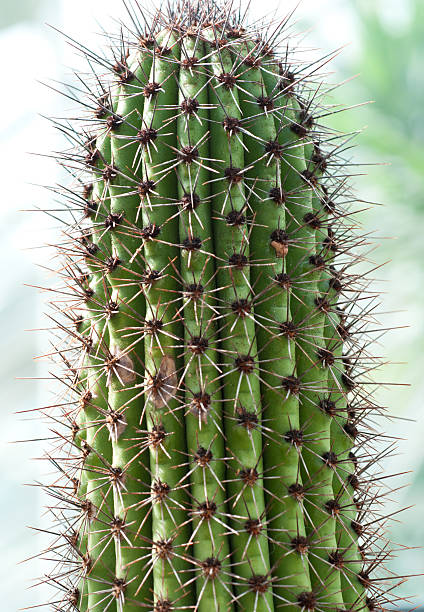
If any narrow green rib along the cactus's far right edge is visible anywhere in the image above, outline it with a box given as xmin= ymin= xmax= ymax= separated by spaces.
xmin=308 ymin=143 xmax=365 ymax=609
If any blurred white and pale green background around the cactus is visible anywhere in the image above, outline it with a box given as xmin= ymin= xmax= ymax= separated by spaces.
xmin=0 ymin=0 xmax=424 ymax=612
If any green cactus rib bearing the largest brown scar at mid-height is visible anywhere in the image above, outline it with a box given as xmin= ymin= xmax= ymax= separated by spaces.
xmin=142 ymin=30 xmax=192 ymax=606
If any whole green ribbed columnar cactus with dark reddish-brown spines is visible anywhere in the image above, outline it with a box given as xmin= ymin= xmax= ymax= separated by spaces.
xmin=34 ymin=0 xmax=410 ymax=612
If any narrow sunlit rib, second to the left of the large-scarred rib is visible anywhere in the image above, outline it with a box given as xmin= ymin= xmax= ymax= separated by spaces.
xmin=80 ymin=125 xmax=114 ymax=610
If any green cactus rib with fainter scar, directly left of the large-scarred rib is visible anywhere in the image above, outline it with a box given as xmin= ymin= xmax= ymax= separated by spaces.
xmin=108 ymin=48 xmax=156 ymax=612
